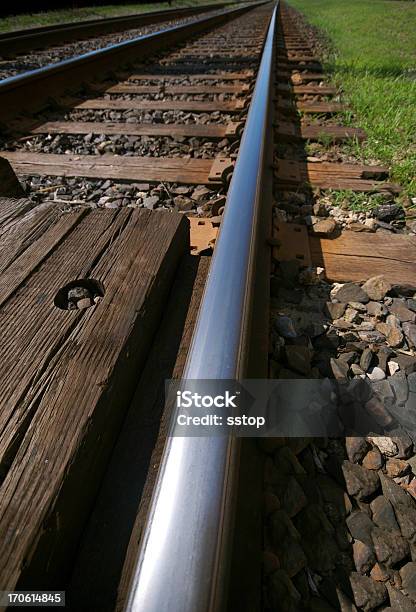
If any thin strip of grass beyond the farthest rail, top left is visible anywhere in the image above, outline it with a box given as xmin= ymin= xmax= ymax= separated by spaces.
xmin=0 ymin=0 xmax=228 ymax=32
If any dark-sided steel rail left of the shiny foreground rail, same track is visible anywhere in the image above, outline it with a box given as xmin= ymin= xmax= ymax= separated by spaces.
xmin=0 ymin=0 xmax=264 ymax=123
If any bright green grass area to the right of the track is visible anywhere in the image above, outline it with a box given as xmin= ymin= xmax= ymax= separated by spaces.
xmin=290 ymin=0 xmax=416 ymax=196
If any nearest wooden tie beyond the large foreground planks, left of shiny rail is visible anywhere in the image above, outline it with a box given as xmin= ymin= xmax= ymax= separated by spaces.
xmin=3 ymin=151 xmax=231 ymax=185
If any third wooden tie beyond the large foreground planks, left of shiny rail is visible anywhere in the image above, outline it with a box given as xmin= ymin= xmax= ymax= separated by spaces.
xmin=69 ymin=98 xmax=244 ymax=113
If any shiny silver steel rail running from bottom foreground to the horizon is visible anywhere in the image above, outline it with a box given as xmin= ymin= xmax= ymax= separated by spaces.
xmin=126 ymin=2 xmax=277 ymax=612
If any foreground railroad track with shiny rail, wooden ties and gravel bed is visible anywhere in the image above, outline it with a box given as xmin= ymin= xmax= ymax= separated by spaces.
xmin=0 ymin=4 xmax=416 ymax=612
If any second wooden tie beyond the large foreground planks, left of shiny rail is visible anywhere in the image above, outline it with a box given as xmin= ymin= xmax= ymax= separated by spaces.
xmin=32 ymin=121 xmax=241 ymax=138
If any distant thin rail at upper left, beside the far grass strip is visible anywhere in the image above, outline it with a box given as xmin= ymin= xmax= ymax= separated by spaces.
xmin=0 ymin=2 xmax=231 ymax=57
